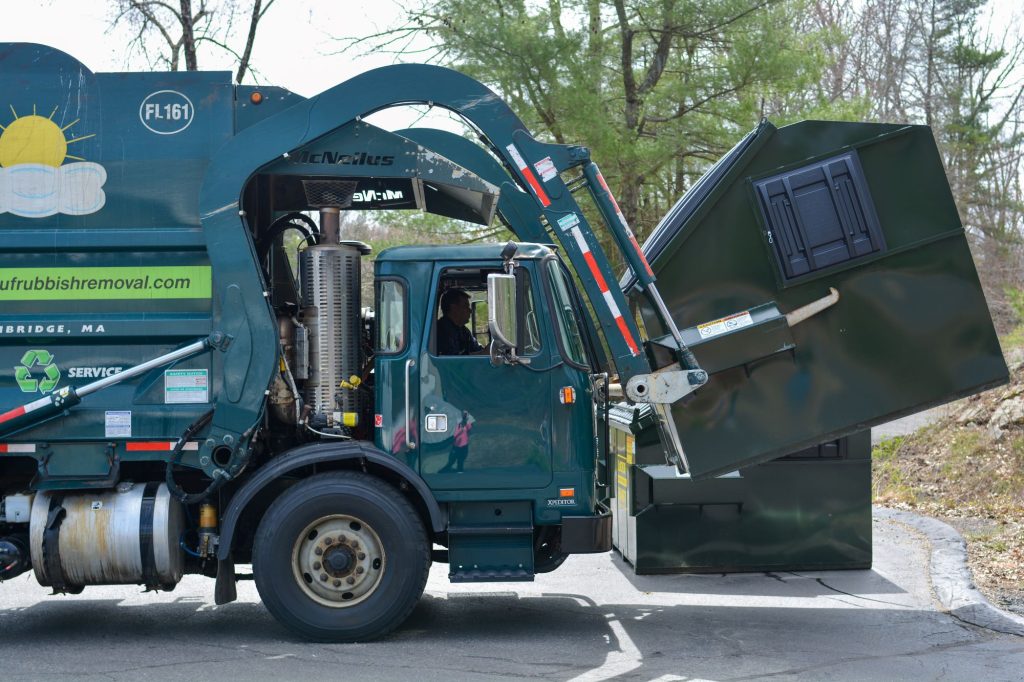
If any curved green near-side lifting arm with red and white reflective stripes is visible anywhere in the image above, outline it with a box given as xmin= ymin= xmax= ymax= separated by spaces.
xmin=200 ymin=65 xmax=707 ymax=466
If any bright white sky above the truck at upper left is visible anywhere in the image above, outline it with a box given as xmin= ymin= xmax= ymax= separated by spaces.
xmin=0 ymin=0 xmax=419 ymax=97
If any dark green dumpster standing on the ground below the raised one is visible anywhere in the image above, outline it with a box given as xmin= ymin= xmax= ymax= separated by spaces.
xmin=611 ymin=411 xmax=871 ymax=573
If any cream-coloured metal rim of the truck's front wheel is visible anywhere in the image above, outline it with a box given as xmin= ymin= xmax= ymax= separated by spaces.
xmin=292 ymin=514 xmax=385 ymax=608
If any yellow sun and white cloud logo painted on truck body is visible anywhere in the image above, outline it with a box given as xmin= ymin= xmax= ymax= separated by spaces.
xmin=0 ymin=102 xmax=106 ymax=218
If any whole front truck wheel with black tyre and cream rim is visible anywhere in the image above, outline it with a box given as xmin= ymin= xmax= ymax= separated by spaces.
xmin=253 ymin=471 xmax=430 ymax=642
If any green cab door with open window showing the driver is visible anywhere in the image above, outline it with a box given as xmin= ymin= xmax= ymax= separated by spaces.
xmin=418 ymin=264 xmax=552 ymax=489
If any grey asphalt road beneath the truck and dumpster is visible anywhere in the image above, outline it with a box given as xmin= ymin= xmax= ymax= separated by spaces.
xmin=0 ymin=512 xmax=1024 ymax=682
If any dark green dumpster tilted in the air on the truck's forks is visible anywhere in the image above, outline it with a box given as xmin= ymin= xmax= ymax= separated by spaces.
xmin=622 ymin=121 xmax=1008 ymax=477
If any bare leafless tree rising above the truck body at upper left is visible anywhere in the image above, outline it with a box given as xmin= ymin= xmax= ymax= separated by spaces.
xmin=111 ymin=0 xmax=276 ymax=83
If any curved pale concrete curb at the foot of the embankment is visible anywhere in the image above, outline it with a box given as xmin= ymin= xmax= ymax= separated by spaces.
xmin=872 ymin=507 xmax=1024 ymax=637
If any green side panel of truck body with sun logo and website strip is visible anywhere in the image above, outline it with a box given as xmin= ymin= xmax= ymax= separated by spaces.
xmin=0 ymin=45 xmax=233 ymax=477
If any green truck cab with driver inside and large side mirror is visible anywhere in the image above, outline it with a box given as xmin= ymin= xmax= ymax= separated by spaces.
xmin=374 ymin=243 xmax=609 ymax=581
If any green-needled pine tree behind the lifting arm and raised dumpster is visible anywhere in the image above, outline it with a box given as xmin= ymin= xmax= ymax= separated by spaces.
xmin=355 ymin=0 xmax=835 ymax=237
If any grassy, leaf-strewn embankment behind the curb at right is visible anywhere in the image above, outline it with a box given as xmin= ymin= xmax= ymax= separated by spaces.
xmin=872 ymin=294 xmax=1024 ymax=613
